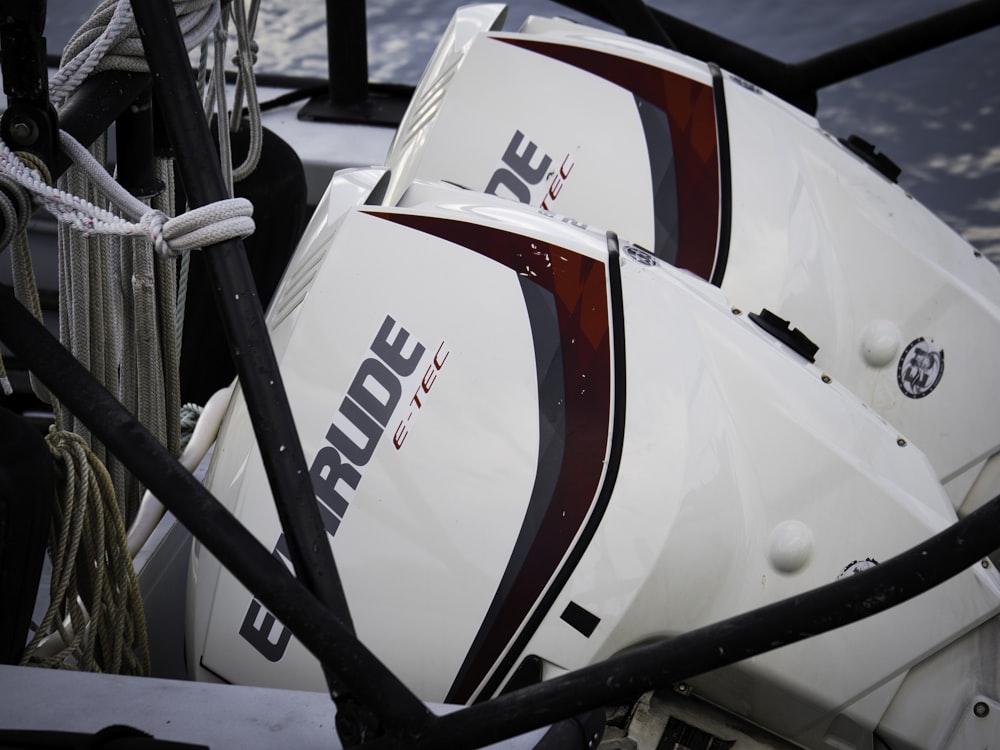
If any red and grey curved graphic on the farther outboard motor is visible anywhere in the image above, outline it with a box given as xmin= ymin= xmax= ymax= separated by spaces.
xmin=493 ymin=37 xmax=720 ymax=281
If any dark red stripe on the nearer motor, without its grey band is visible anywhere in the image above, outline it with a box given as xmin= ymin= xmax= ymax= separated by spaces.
xmin=366 ymin=211 xmax=612 ymax=702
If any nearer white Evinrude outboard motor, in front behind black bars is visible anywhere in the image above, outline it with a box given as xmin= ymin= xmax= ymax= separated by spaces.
xmin=188 ymin=170 xmax=1000 ymax=747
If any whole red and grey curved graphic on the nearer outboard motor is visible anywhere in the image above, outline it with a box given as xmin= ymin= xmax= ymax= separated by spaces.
xmin=366 ymin=211 xmax=613 ymax=702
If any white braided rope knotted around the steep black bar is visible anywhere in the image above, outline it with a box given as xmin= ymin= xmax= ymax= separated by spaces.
xmin=0 ymin=132 xmax=254 ymax=257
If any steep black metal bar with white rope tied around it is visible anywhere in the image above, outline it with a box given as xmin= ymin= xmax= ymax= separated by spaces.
xmin=127 ymin=0 xmax=353 ymax=693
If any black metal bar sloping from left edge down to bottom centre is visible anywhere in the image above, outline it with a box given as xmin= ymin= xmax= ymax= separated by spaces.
xmin=0 ymin=285 xmax=434 ymax=736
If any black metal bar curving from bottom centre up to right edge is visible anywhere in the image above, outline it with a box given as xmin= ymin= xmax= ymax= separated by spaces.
xmin=402 ymin=497 xmax=1000 ymax=750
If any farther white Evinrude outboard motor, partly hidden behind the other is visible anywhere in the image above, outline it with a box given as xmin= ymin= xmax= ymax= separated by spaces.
xmin=386 ymin=5 xmax=1000 ymax=514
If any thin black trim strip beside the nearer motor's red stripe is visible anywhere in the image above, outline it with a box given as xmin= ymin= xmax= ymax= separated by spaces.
xmin=474 ymin=232 xmax=625 ymax=703
